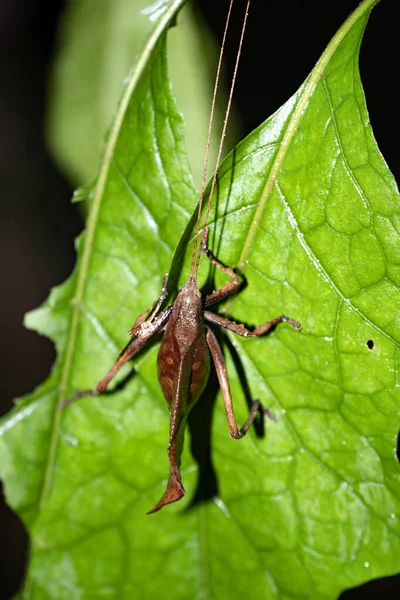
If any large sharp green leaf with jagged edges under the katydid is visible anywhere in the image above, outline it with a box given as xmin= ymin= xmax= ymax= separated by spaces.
xmin=0 ymin=0 xmax=400 ymax=600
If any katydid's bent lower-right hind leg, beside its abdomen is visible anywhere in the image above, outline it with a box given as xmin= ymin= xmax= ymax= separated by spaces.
xmin=206 ymin=329 xmax=263 ymax=440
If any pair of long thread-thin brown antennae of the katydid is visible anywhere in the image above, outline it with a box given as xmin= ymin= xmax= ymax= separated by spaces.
xmin=190 ymin=0 xmax=251 ymax=277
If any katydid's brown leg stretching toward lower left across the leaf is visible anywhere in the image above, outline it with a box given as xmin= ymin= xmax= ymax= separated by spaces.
xmin=59 ymin=306 xmax=172 ymax=408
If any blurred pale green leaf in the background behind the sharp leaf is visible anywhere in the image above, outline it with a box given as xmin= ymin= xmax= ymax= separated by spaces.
xmin=47 ymin=0 xmax=236 ymax=185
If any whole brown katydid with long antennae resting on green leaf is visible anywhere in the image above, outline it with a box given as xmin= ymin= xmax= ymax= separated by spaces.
xmin=61 ymin=0 xmax=300 ymax=513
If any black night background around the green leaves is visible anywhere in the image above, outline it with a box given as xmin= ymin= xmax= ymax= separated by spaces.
xmin=0 ymin=0 xmax=400 ymax=600
